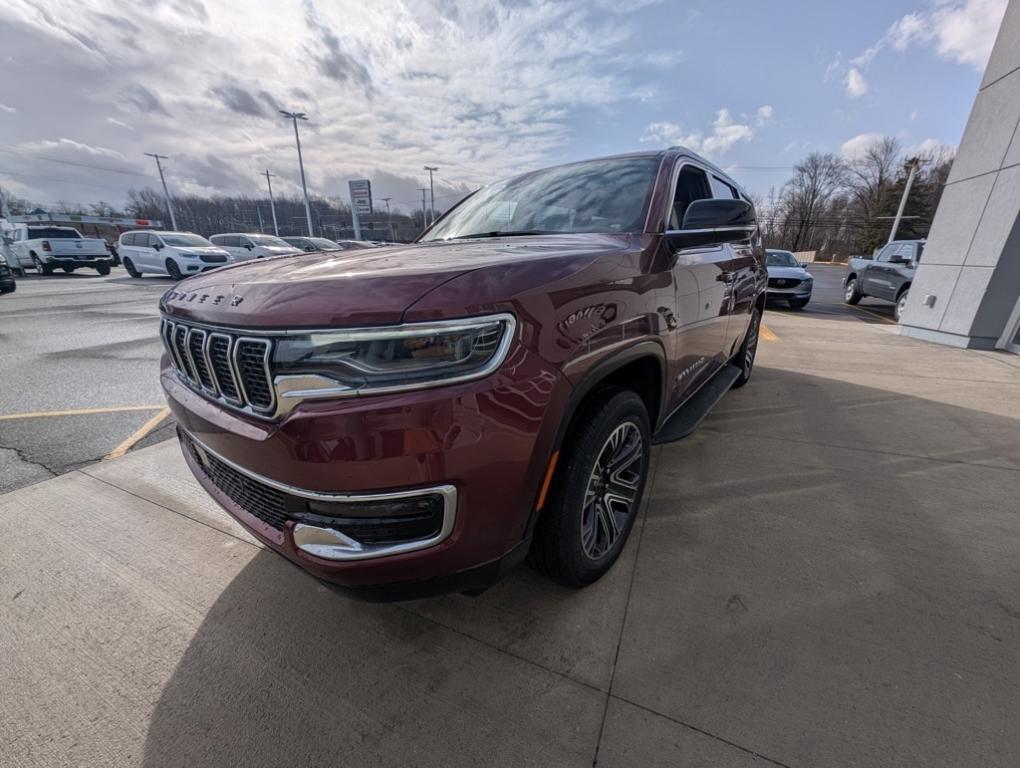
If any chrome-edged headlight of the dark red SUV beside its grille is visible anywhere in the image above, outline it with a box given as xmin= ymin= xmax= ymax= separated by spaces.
xmin=273 ymin=314 xmax=516 ymax=395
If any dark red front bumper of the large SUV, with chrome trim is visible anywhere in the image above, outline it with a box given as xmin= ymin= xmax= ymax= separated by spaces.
xmin=161 ymin=344 xmax=569 ymax=599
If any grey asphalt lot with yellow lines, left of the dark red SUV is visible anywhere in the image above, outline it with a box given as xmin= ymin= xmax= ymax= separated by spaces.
xmin=0 ymin=268 xmax=172 ymax=493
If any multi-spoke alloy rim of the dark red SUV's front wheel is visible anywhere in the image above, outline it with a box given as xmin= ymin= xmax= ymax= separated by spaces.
xmin=580 ymin=421 xmax=645 ymax=560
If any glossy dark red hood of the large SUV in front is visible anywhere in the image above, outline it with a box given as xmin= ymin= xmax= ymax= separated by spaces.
xmin=160 ymin=235 xmax=626 ymax=328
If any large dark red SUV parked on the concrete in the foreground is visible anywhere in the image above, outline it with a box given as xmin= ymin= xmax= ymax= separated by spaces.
xmin=161 ymin=149 xmax=767 ymax=599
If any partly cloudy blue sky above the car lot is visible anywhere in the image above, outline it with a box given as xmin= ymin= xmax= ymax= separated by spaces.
xmin=0 ymin=0 xmax=1007 ymax=210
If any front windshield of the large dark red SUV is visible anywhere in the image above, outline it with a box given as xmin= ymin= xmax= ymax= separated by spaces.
xmin=421 ymin=156 xmax=659 ymax=242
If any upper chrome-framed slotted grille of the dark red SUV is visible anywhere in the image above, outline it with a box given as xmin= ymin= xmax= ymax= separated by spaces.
xmin=160 ymin=317 xmax=276 ymax=416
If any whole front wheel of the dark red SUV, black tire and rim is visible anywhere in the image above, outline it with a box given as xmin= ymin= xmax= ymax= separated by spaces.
xmin=530 ymin=387 xmax=652 ymax=588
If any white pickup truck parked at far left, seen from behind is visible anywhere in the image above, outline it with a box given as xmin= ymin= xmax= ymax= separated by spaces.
xmin=4 ymin=224 xmax=113 ymax=274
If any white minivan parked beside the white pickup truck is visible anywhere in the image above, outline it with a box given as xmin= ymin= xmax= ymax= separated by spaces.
xmin=117 ymin=229 xmax=234 ymax=280
